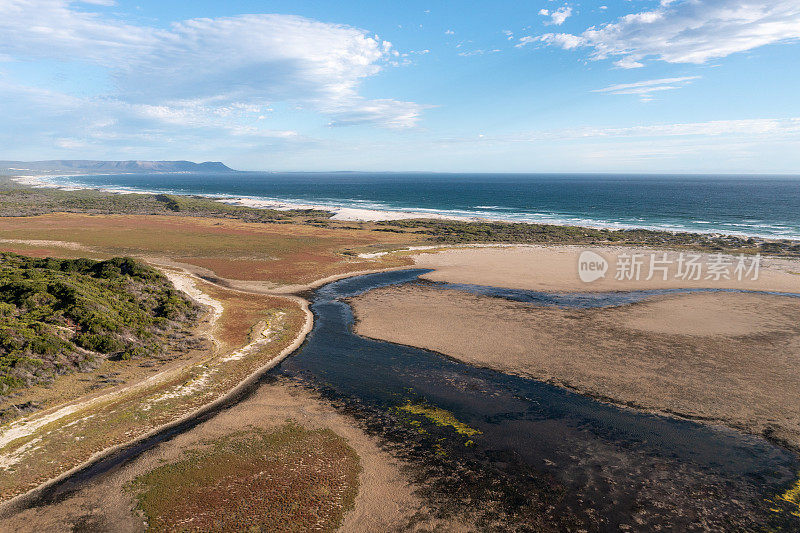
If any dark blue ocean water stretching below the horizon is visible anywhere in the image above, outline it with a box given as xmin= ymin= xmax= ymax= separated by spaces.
xmin=43 ymin=172 xmax=800 ymax=239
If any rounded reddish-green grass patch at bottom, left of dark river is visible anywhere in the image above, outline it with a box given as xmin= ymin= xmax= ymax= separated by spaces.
xmin=130 ymin=422 xmax=361 ymax=532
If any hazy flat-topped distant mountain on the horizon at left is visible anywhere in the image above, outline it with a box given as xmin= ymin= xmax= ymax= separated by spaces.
xmin=0 ymin=159 xmax=235 ymax=173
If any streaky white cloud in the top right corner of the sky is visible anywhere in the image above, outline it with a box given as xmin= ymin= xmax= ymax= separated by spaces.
xmin=520 ymin=0 xmax=800 ymax=68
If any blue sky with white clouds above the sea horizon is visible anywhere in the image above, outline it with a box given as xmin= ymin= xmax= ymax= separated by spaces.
xmin=0 ymin=0 xmax=800 ymax=170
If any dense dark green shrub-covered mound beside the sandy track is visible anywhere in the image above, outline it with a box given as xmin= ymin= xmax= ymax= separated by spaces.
xmin=0 ymin=253 xmax=201 ymax=399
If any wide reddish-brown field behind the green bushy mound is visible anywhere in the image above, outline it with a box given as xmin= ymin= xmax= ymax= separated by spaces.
xmin=0 ymin=213 xmax=411 ymax=284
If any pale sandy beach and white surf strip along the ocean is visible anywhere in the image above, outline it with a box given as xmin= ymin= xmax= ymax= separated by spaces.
xmin=9 ymin=174 xmax=800 ymax=242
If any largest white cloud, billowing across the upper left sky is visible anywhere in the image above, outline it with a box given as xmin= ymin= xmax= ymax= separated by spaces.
xmin=0 ymin=0 xmax=421 ymax=127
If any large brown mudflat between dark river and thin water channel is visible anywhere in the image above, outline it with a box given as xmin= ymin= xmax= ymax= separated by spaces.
xmin=352 ymin=285 xmax=800 ymax=448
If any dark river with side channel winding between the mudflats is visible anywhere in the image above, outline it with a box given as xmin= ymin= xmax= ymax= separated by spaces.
xmin=274 ymin=269 xmax=800 ymax=531
